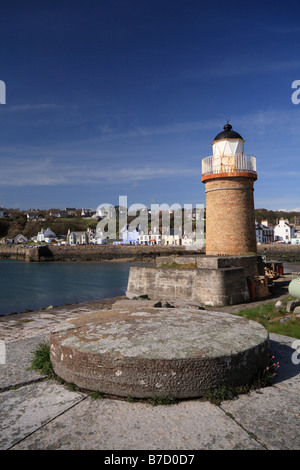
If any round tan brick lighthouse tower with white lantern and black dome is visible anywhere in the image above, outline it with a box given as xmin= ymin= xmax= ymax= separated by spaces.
xmin=202 ymin=123 xmax=257 ymax=256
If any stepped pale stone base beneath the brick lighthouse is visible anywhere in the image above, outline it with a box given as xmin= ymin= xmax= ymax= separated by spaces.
xmin=126 ymin=255 xmax=269 ymax=306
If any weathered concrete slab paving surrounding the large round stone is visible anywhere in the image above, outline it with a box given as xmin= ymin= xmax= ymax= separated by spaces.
xmin=0 ymin=282 xmax=300 ymax=455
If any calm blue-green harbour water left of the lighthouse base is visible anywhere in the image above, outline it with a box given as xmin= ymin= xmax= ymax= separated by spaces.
xmin=0 ymin=260 xmax=138 ymax=315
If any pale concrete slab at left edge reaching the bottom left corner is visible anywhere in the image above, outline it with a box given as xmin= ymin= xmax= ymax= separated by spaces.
xmin=0 ymin=381 xmax=85 ymax=450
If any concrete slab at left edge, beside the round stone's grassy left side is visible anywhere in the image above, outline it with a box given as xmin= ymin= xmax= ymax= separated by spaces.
xmin=0 ymin=335 xmax=49 ymax=392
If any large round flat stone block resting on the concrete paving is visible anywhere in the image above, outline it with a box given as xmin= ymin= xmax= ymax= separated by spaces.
xmin=50 ymin=307 xmax=270 ymax=398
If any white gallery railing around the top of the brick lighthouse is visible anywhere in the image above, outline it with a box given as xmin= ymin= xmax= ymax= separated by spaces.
xmin=202 ymin=153 xmax=256 ymax=176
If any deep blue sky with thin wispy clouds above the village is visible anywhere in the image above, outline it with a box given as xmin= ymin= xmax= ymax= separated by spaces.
xmin=0 ymin=0 xmax=300 ymax=210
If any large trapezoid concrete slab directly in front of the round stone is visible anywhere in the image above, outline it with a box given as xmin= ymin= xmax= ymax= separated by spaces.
xmin=14 ymin=398 xmax=263 ymax=450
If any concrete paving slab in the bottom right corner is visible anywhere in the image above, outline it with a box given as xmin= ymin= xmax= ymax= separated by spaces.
xmin=221 ymin=386 xmax=300 ymax=450
